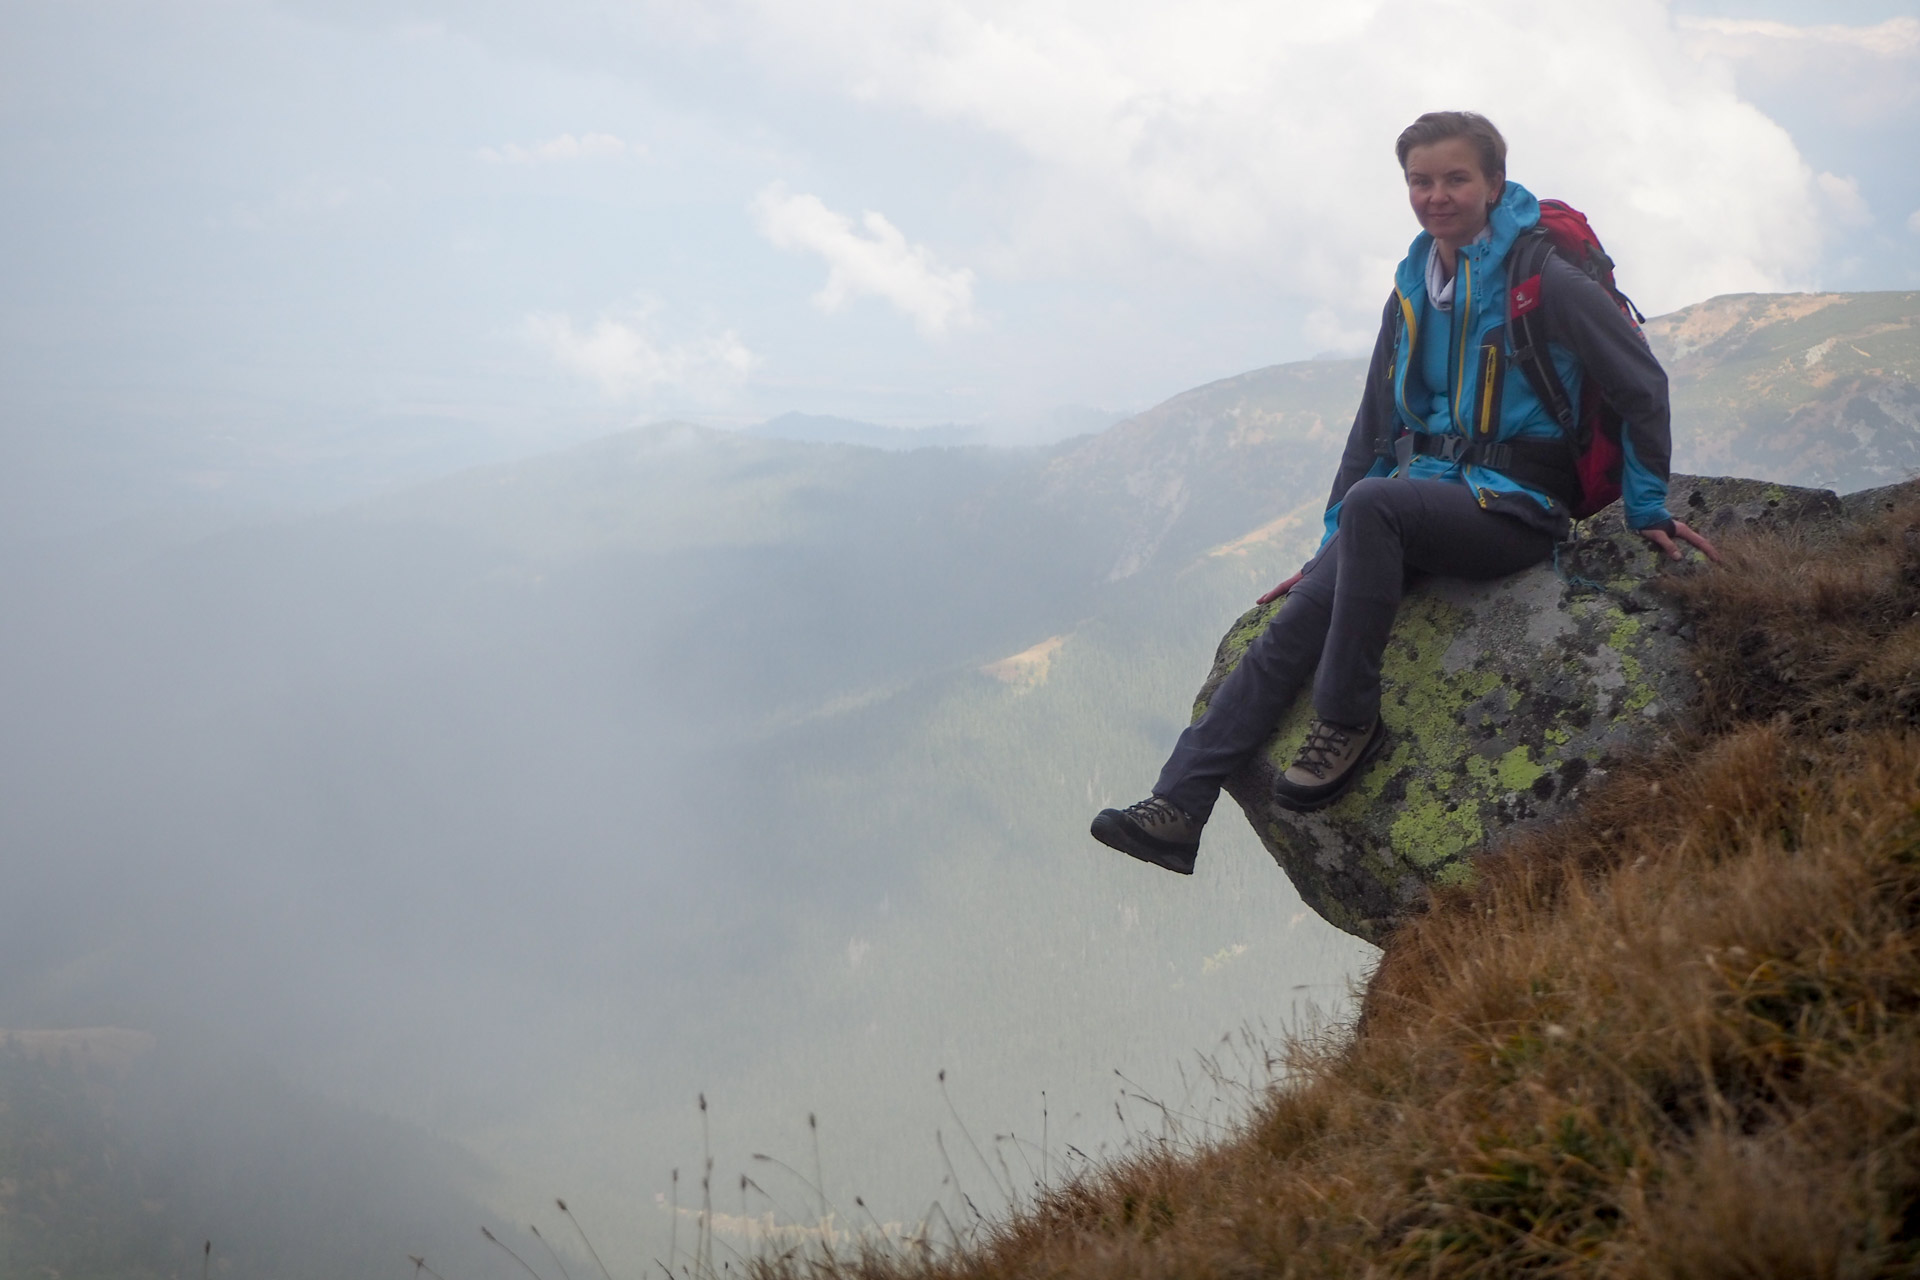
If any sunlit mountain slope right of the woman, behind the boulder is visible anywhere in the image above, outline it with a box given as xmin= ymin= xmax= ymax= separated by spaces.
xmin=1647 ymin=294 xmax=1920 ymax=491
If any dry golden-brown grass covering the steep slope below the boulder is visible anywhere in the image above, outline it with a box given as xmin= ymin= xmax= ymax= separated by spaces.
xmin=762 ymin=485 xmax=1920 ymax=1280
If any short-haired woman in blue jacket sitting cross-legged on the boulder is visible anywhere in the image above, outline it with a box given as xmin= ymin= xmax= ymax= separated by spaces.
xmin=1092 ymin=111 xmax=1718 ymax=875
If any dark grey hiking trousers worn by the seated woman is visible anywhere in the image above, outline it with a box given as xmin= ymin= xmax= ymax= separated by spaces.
xmin=1154 ymin=478 xmax=1553 ymax=821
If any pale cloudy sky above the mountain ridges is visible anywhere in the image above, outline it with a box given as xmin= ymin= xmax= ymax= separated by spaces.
xmin=0 ymin=0 xmax=1920 ymax=521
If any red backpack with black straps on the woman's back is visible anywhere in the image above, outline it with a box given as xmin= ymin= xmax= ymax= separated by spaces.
xmin=1507 ymin=200 xmax=1647 ymax=520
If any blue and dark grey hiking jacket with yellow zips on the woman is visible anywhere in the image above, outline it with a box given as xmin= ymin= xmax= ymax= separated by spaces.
xmin=1323 ymin=182 xmax=1672 ymax=545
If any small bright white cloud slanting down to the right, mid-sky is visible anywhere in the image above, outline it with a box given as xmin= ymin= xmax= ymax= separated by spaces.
xmin=753 ymin=182 xmax=973 ymax=338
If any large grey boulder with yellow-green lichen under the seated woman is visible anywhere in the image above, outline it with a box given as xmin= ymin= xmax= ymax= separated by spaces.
xmin=1194 ymin=476 xmax=1853 ymax=942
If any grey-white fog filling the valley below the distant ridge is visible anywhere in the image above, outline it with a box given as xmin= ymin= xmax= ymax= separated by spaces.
xmin=0 ymin=412 xmax=1367 ymax=1272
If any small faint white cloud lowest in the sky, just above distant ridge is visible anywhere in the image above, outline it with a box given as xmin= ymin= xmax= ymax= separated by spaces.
xmin=524 ymin=313 xmax=758 ymax=399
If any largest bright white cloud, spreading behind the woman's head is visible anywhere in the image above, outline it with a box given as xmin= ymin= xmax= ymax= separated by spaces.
xmin=695 ymin=0 xmax=1826 ymax=320
